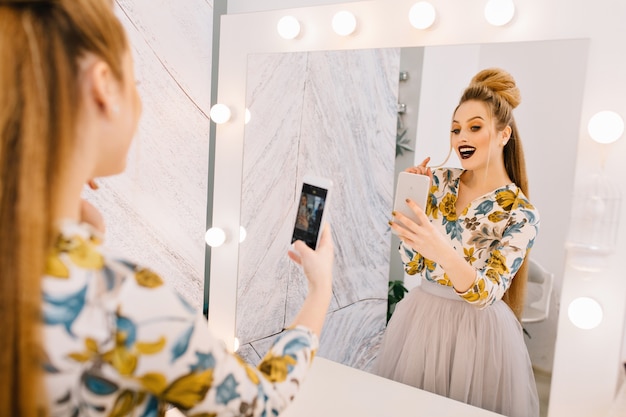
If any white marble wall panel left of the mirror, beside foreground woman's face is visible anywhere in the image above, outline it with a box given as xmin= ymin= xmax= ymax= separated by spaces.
xmin=85 ymin=0 xmax=213 ymax=309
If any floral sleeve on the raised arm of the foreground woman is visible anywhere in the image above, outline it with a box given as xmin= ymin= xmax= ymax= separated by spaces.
xmin=105 ymin=269 xmax=318 ymax=416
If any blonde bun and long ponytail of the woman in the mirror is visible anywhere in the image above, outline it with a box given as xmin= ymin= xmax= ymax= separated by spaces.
xmin=455 ymin=68 xmax=528 ymax=320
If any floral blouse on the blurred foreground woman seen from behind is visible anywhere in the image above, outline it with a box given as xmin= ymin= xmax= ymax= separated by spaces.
xmin=42 ymin=222 xmax=318 ymax=417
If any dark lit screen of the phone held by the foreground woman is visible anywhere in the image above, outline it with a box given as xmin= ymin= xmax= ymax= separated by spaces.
xmin=291 ymin=183 xmax=328 ymax=249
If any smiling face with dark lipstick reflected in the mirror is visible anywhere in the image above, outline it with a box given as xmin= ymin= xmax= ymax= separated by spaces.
xmin=450 ymin=100 xmax=508 ymax=171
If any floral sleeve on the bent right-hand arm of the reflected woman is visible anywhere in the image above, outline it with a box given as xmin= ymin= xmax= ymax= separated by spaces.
xmin=458 ymin=208 xmax=539 ymax=308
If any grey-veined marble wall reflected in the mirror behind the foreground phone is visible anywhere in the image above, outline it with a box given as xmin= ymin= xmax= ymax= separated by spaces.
xmin=237 ymin=49 xmax=400 ymax=369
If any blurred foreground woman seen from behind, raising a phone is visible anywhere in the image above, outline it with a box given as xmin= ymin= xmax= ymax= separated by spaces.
xmin=0 ymin=0 xmax=333 ymax=417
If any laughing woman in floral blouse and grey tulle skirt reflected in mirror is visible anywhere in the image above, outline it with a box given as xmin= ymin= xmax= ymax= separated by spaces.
xmin=375 ymin=68 xmax=539 ymax=417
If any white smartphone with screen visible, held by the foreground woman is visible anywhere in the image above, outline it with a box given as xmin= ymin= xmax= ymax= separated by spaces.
xmin=291 ymin=175 xmax=333 ymax=249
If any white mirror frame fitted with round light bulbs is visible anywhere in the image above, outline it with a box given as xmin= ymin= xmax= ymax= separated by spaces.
xmin=209 ymin=0 xmax=626 ymax=417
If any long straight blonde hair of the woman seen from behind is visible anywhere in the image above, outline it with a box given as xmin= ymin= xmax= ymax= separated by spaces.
xmin=0 ymin=0 xmax=128 ymax=417
